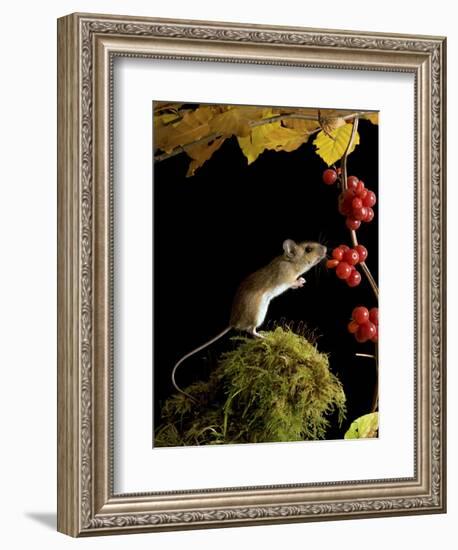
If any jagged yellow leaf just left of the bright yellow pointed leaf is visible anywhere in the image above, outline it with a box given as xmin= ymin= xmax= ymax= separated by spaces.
xmin=237 ymin=122 xmax=308 ymax=164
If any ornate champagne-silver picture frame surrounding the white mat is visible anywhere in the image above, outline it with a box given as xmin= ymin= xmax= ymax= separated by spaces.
xmin=58 ymin=14 xmax=446 ymax=536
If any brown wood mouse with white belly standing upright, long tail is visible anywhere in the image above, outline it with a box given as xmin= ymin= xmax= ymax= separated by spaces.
xmin=172 ymin=239 xmax=327 ymax=400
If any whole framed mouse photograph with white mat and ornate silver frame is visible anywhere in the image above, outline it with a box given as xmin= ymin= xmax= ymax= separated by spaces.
xmin=58 ymin=14 xmax=446 ymax=536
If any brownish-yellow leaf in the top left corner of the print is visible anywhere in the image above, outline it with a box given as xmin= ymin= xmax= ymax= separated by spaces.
xmin=154 ymin=106 xmax=217 ymax=153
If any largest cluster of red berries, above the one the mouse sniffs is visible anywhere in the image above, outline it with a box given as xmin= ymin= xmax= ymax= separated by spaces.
xmin=339 ymin=176 xmax=377 ymax=231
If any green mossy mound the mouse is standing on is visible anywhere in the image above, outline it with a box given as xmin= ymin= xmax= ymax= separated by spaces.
xmin=154 ymin=327 xmax=345 ymax=447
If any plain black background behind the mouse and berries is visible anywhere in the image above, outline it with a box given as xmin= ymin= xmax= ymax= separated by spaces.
xmin=153 ymin=114 xmax=378 ymax=438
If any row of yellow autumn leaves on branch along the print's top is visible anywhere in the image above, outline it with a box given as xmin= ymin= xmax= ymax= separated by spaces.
xmin=154 ymin=102 xmax=378 ymax=176
